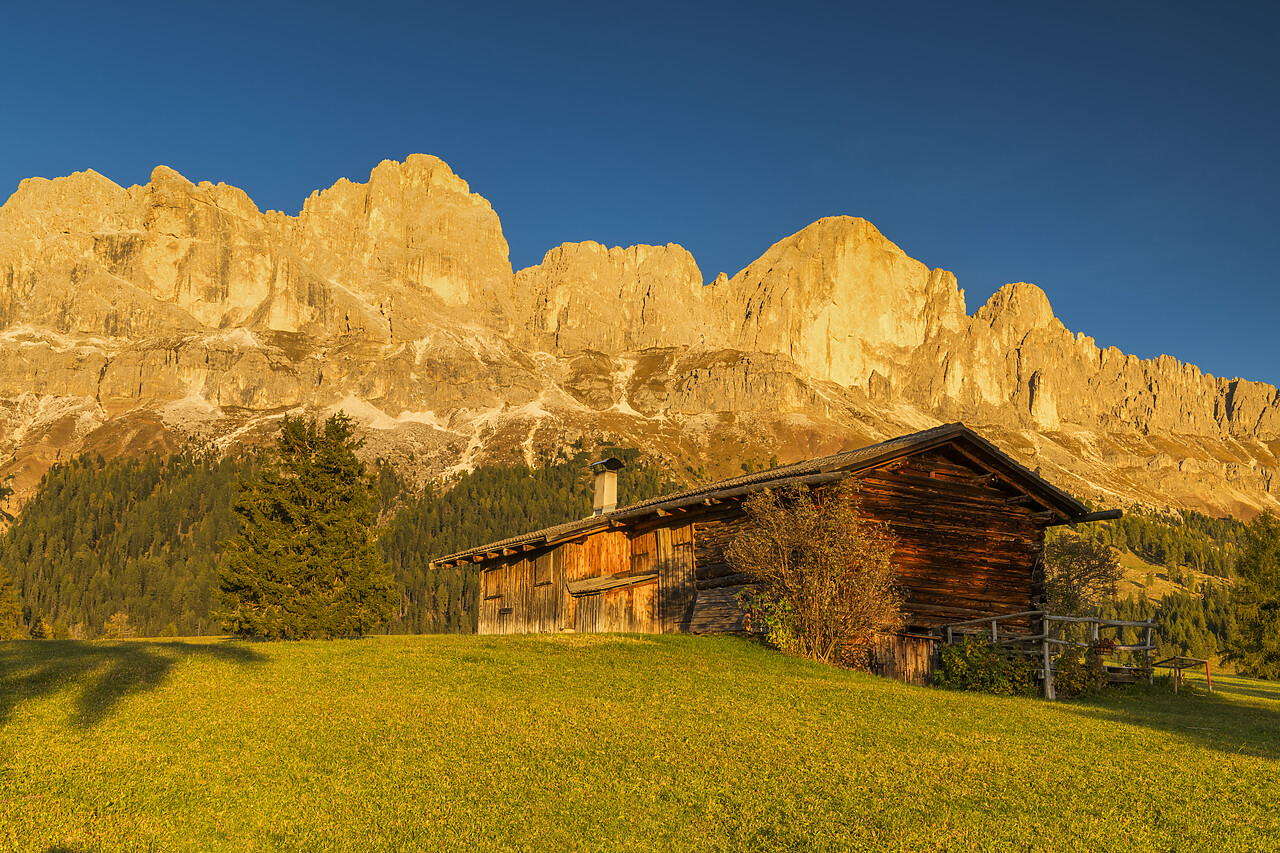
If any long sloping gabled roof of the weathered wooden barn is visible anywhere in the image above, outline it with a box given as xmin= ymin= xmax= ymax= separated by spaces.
xmin=433 ymin=423 xmax=1089 ymax=565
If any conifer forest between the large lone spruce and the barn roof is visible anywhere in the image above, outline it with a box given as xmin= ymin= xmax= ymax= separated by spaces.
xmin=378 ymin=447 xmax=678 ymax=634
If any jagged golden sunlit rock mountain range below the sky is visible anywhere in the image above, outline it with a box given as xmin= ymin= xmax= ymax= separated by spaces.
xmin=0 ymin=155 xmax=1280 ymax=515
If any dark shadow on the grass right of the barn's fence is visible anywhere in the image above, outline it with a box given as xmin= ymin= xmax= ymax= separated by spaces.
xmin=1064 ymin=678 xmax=1280 ymax=758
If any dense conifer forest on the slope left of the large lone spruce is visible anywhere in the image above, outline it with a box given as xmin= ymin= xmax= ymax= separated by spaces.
xmin=0 ymin=450 xmax=255 ymax=639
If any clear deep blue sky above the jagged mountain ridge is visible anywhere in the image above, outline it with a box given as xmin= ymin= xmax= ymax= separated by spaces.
xmin=0 ymin=0 xmax=1280 ymax=384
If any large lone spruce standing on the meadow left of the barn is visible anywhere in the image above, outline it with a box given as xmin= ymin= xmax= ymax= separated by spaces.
xmin=220 ymin=412 xmax=396 ymax=639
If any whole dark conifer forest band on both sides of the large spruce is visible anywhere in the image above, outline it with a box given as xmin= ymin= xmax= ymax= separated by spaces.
xmin=0 ymin=435 xmax=680 ymax=639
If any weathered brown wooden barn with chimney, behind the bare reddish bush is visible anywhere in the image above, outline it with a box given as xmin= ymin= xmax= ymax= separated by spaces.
xmin=436 ymin=424 xmax=1111 ymax=680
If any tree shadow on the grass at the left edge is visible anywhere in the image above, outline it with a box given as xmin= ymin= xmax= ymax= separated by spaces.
xmin=0 ymin=640 xmax=266 ymax=729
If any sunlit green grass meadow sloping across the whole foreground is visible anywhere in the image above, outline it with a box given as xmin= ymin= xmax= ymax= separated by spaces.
xmin=0 ymin=635 xmax=1280 ymax=853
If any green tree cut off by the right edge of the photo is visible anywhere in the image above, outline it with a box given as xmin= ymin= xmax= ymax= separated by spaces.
xmin=1226 ymin=512 xmax=1280 ymax=679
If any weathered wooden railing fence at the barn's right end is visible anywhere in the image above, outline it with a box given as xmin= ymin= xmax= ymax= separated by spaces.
xmin=937 ymin=610 xmax=1156 ymax=699
